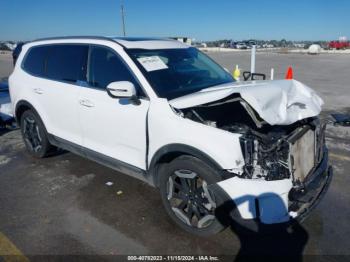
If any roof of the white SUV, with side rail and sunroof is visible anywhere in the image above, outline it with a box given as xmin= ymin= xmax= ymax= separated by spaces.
xmin=31 ymin=36 xmax=189 ymax=49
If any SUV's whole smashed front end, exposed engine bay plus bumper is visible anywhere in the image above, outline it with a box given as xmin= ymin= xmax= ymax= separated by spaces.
xmin=176 ymin=90 xmax=332 ymax=224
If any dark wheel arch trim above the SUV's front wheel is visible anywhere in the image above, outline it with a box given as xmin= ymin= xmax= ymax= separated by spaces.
xmin=148 ymin=144 xmax=224 ymax=187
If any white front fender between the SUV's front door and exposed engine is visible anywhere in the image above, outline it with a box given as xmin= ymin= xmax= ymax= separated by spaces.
xmin=148 ymin=99 xmax=244 ymax=170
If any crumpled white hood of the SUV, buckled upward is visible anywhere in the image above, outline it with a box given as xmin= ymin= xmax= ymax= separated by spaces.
xmin=169 ymin=80 xmax=323 ymax=125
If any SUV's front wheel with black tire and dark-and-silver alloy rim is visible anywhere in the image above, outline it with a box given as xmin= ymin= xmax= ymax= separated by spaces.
xmin=159 ymin=155 xmax=225 ymax=236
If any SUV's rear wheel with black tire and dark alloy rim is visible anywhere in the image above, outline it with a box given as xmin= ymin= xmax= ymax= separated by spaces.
xmin=20 ymin=110 xmax=53 ymax=158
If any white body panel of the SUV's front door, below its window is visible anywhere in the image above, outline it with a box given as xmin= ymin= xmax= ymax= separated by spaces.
xmin=77 ymin=85 xmax=150 ymax=169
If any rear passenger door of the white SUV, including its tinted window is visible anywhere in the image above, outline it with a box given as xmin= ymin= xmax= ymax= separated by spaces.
xmin=34 ymin=44 xmax=89 ymax=145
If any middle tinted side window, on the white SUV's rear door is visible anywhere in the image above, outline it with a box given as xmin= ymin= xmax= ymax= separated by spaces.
xmin=46 ymin=45 xmax=89 ymax=83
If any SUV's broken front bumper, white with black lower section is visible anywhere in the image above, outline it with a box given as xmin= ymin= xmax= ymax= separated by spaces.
xmin=209 ymin=151 xmax=333 ymax=224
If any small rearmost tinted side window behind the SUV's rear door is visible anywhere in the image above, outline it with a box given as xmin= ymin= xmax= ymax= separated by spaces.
xmin=23 ymin=46 xmax=47 ymax=76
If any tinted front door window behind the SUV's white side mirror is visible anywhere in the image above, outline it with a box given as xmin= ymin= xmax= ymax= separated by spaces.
xmin=88 ymin=46 xmax=142 ymax=95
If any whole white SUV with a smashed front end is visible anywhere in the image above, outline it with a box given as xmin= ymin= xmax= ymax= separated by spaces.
xmin=9 ymin=37 xmax=332 ymax=235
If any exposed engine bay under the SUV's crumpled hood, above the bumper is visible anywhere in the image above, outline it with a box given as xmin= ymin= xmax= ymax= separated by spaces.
xmin=178 ymin=95 xmax=324 ymax=183
